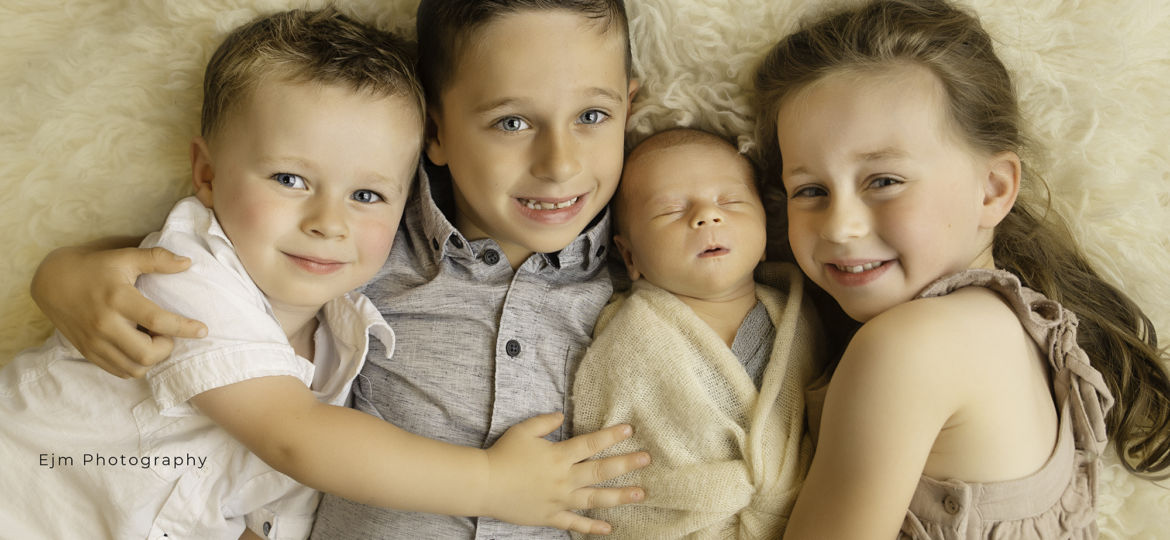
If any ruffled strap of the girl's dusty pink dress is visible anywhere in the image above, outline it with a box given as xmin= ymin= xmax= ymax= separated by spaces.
xmin=920 ymin=269 xmax=1114 ymax=455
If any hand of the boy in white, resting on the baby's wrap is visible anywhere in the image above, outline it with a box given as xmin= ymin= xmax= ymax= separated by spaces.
xmin=484 ymin=413 xmax=651 ymax=534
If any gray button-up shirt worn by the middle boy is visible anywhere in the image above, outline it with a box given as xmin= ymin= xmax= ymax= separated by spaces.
xmin=312 ymin=166 xmax=613 ymax=540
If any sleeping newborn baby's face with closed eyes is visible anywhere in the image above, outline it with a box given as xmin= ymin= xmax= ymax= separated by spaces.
xmin=615 ymin=141 xmax=765 ymax=302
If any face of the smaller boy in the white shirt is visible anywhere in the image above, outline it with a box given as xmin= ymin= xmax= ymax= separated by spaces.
xmin=195 ymin=82 xmax=421 ymax=311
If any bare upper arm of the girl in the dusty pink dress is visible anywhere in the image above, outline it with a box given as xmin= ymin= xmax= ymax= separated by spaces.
xmin=784 ymin=312 xmax=962 ymax=540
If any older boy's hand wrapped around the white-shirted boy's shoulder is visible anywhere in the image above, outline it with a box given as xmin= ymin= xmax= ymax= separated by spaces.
xmin=30 ymin=243 xmax=207 ymax=378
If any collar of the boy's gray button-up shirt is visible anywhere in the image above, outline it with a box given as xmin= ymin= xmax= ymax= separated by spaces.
xmin=407 ymin=159 xmax=610 ymax=275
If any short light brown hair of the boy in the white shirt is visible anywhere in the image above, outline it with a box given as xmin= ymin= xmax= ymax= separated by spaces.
xmin=200 ymin=7 xmax=426 ymax=138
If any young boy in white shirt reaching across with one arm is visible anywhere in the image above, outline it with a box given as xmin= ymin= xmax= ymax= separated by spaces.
xmin=0 ymin=9 xmax=638 ymax=538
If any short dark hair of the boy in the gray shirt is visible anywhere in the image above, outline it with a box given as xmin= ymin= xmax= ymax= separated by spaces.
xmin=415 ymin=0 xmax=633 ymax=105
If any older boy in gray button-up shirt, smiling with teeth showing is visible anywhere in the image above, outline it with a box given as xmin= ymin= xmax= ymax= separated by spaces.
xmin=33 ymin=0 xmax=641 ymax=540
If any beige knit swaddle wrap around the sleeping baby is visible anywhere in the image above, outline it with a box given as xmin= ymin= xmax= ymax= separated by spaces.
xmin=573 ymin=264 xmax=821 ymax=540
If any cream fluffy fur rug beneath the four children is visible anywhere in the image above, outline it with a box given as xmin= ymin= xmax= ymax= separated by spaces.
xmin=0 ymin=0 xmax=1170 ymax=532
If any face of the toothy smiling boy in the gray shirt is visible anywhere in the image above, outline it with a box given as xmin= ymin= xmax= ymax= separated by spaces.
xmin=427 ymin=9 xmax=635 ymax=268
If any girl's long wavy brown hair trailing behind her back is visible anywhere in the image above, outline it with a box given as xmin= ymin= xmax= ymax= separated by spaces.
xmin=756 ymin=0 xmax=1170 ymax=477
